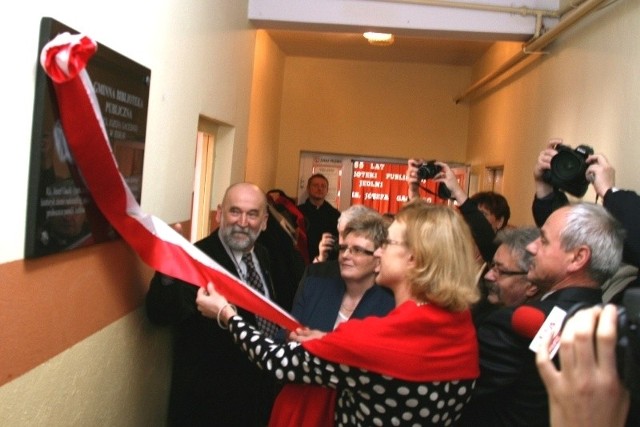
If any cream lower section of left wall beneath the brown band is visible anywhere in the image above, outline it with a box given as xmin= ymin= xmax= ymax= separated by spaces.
xmin=0 ymin=309 xmax=171 ymax=427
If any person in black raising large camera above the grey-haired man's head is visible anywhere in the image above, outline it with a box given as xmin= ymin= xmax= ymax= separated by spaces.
xmin=532 ymin=139 xmax=640 ymax=303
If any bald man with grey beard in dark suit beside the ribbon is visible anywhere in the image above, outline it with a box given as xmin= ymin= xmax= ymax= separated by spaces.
xmin=146 ymin=183 xmax=290 ymax=427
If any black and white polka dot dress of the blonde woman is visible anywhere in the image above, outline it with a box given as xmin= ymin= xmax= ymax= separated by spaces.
xmin=229 ymin=316 xmax=474 ymax=427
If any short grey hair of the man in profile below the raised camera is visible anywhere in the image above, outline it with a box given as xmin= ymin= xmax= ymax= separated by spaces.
xmin=560 ymin=202 xmax=625 ymax=284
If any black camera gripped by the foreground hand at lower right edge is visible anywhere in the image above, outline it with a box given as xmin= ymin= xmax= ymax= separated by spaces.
xmin=564 ymin=289 xmax=640 ymax=398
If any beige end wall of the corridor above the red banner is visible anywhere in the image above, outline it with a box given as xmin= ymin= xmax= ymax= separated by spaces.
xmin=276 ymin=57 xmax=471 ymax=196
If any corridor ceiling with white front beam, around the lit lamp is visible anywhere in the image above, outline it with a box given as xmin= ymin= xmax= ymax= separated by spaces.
xmin=248 ymin=0 xmax=560 ymax=65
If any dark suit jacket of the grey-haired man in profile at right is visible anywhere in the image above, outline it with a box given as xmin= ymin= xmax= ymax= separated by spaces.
xmin=460 ymin=287 xmax=602 ymax=427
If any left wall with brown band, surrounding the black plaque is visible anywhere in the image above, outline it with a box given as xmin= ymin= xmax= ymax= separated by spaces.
xmin=0 ymin=0 xmax=255 ymax=427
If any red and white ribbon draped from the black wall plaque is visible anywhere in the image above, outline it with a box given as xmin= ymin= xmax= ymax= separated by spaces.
xmin=40 ymin=33 xmax=299 ymax=330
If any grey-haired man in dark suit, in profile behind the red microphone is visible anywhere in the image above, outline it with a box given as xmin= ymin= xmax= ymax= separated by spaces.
xmin=461 ymin=203 xmax=624 ymax=427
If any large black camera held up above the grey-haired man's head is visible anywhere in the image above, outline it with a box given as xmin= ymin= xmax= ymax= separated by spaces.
xmin=542 ymin=144 xmax=593 ymax=197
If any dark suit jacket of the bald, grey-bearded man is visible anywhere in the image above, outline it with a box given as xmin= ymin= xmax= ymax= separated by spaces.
xmin=145 ymin=230 xmax=286 ymax=427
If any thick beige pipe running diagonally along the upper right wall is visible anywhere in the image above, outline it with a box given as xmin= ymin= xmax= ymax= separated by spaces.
xmin=453 ymin=0 xmax=605 ymax=104
